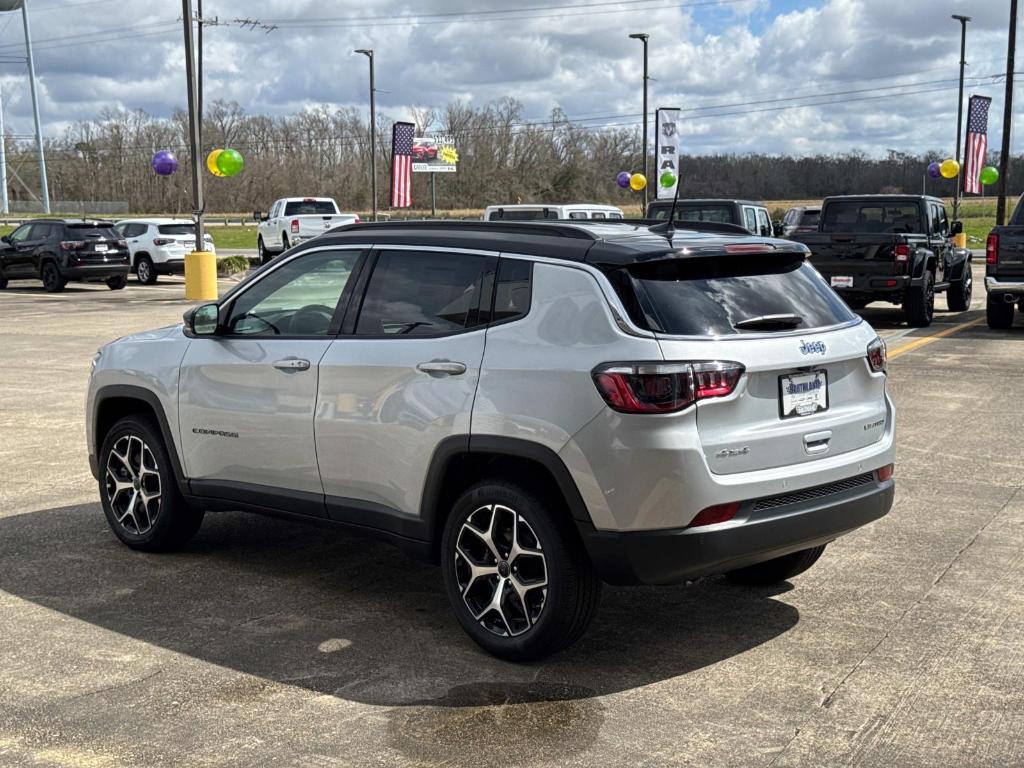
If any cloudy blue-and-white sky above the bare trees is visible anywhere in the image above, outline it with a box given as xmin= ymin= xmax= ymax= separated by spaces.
xmin=0 ymin=0 xmax=1011 ymax=155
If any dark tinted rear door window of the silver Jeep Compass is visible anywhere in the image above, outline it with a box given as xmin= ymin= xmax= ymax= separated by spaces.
xmin=355 ymin=251 xmax=486 ymax=336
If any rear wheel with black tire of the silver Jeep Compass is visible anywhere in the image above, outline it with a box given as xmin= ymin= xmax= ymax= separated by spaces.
xmin=441 ymin=480 xmax=601 ymax=662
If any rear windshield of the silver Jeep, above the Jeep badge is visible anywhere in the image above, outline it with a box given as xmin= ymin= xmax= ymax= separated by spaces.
xmin=613 ymin=254 xmax=856 ymax=336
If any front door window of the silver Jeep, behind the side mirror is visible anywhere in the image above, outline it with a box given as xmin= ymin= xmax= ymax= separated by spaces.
xmin=227 ymin=251 xmax=359 ymax=336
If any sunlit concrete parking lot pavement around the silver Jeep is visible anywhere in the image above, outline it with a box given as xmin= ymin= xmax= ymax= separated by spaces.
xmin=0 ymin=268 xmax=1024 ymax=768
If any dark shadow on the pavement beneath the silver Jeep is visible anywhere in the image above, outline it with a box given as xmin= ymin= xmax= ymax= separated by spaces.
xmin=0 ymin=504 xmax=799 ymax=724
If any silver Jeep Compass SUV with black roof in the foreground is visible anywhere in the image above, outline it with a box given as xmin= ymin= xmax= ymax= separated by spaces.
xmin=87 ymin=222 xmax=895 ymax=659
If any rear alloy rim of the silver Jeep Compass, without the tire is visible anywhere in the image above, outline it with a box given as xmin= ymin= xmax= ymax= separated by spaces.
xmin=455 ymin=504 xmax=548 ymax=637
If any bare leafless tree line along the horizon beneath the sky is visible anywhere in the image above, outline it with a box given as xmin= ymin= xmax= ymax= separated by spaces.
xmin=5 ymin=99 xmax=1024 ymax=213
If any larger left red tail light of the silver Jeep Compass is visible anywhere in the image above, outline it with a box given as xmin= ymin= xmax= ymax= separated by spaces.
xmin=593 ymin=360 xmax=743 ymax=414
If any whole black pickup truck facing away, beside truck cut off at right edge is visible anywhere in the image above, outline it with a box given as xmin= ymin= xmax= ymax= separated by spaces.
xmin=792 ymin=195 xmax=973 ymax=327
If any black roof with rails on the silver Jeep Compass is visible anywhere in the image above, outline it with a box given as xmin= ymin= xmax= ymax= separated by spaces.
xmin=303 ymin=219 xmax=807 ymax=266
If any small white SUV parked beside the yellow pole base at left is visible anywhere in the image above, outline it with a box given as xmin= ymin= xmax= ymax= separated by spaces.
xmin=114 ymin=218 xmax=216 ymax=286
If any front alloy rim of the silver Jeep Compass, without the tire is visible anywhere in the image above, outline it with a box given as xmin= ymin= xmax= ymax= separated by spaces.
xmin=105 ymin=434 xmax=162 ymax=535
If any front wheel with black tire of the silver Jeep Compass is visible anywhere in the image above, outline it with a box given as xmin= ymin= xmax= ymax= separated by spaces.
xmin=99 ymin=416 xmax=203 ymax=552
